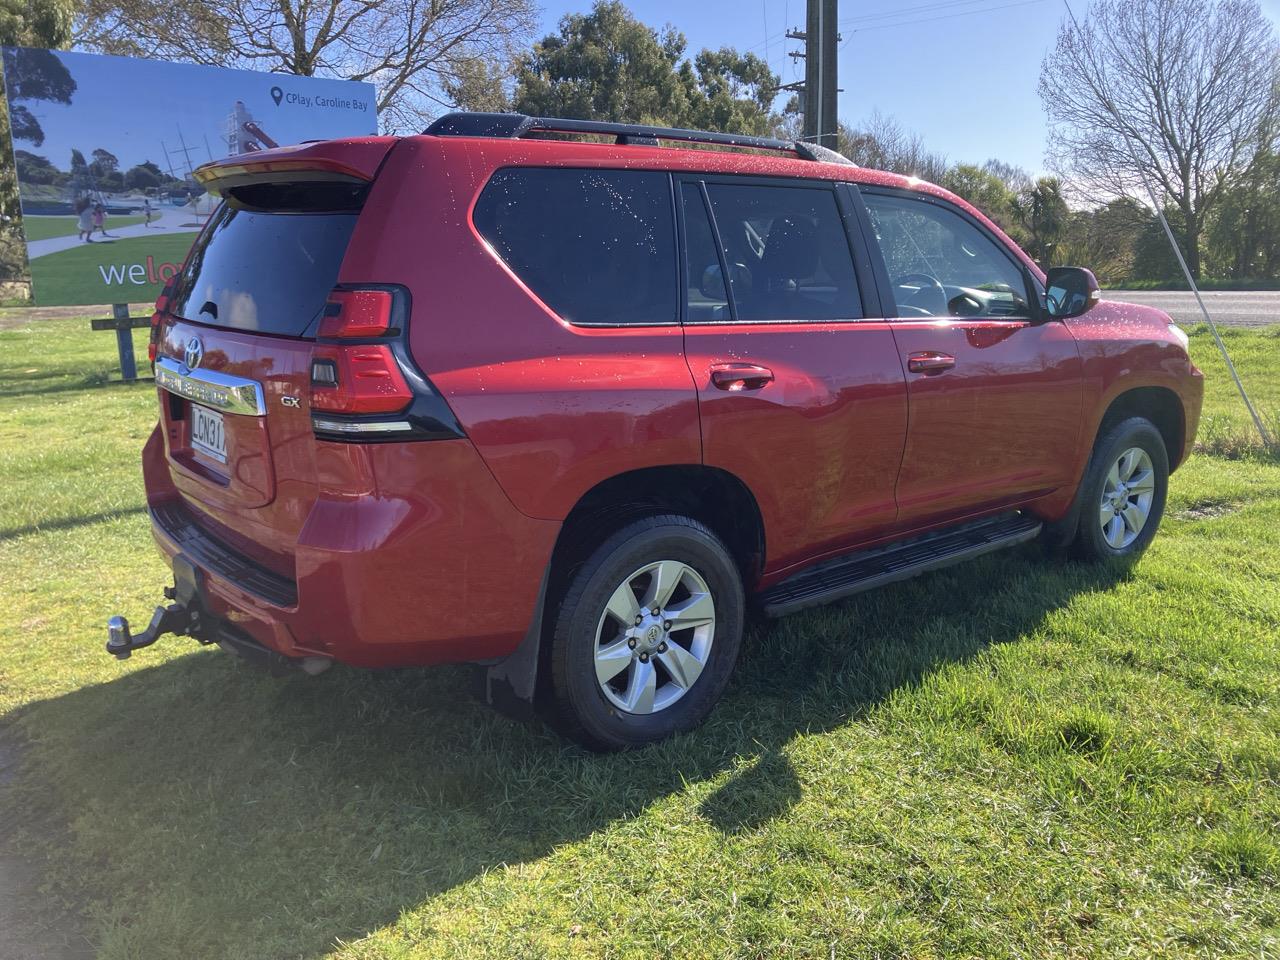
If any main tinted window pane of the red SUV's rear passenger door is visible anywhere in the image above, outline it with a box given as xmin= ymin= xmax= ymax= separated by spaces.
xmin=689 ymin=183 xmax=863 ymax=321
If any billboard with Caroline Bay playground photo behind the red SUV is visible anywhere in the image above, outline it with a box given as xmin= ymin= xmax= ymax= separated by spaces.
xmin=4 ymin=47 xmax=378 ymax=306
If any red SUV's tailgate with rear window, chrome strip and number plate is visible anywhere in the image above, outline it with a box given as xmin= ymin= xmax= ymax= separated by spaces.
xmin=156 ymin=163 xmax=386 ymax=576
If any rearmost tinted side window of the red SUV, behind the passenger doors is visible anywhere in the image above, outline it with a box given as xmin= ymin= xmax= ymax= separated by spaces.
xmin=474 ymin=168 xmax=678 ymax=324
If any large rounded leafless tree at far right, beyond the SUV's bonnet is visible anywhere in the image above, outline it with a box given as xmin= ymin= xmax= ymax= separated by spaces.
xmin=1039 ymin=0 xmax=1280 ymax=276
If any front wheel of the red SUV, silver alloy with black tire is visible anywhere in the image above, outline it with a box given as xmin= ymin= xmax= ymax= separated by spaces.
xmin=1071 ymin=417 xmax=1169 ymax=561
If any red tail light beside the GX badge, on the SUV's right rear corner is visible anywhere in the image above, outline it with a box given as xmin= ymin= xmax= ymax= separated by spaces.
xmin=311 ymin=289 xmax=413 ymax=436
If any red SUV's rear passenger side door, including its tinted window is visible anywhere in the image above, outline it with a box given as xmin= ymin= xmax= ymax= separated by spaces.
xmin=677 ymin=177 xmax=906 ymax=572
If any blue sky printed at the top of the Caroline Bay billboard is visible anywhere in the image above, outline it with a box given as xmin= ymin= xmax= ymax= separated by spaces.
xmin=15 ymin=52 xmax=376 ymax=175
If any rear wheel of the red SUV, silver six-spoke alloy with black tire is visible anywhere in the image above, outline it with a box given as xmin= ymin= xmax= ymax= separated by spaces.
xmin=549 ymin=516 xmax=744 ymax=750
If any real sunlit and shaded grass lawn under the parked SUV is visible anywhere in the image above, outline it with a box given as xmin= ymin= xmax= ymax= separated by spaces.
xmin=0 ymin=321 xmax=1280 ymax=960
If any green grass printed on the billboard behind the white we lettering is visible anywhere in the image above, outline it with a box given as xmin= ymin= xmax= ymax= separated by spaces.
xmin=31 ymin=230 xmax=196 ymax=306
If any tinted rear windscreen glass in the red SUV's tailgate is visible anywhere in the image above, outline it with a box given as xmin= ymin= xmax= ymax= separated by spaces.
xmin=169 ymin=201 xmax=357 ymax=337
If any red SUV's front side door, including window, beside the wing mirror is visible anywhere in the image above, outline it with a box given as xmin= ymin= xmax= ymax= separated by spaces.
xmin=860 ymin=187 xmax=1082 ymax=526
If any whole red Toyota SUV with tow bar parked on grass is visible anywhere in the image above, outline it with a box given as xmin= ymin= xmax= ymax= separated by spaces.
xmin=108 ymin=114 xmax=1202 ymax=749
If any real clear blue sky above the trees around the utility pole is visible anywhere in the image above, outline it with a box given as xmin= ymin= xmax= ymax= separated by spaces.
xmin=541 ymin=0 xmax=1280 ymax=174
